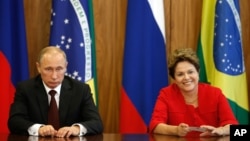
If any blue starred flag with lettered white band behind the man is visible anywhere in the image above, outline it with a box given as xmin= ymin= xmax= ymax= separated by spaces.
xmin=50 ymin=0 xmax=98 ymax=105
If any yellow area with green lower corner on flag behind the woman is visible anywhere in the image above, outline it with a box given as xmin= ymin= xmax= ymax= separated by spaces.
xmin=200 ymin=0 xmax=249 ymax=123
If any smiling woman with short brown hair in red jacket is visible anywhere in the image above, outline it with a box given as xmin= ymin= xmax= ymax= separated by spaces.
xmin=149 ymin=48 xmax=238 ymax=136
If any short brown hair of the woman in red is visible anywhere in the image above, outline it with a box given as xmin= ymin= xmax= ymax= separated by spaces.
xmin=168 ymin=48 xmax=200 ymax=79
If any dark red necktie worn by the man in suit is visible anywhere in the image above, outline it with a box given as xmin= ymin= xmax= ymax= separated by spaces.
xmin=48 ymin=90 xmax=59 ymax=130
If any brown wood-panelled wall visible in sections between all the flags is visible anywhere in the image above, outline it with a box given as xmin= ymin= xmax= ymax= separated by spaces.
xmin=24 ymin=0 xmax=250 ymax=133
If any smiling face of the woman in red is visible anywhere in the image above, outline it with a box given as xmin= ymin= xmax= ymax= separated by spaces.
xmin=174 ymin=61 xmax=199 ymax=92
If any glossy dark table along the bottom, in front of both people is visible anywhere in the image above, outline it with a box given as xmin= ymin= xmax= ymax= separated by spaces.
xmin=0 ymin=133 xmax=230 ymax=141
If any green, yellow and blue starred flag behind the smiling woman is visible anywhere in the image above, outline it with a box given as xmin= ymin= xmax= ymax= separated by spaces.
xmin=197 ymin=0 xmax=249 ymax=124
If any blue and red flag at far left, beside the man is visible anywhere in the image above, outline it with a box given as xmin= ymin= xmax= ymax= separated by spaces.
xmin=0 ymin=0 xmax=29 ymax=133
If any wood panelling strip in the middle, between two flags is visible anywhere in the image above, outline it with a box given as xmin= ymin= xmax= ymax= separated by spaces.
xmin=93 ymin=0 xmax=126 ymax=133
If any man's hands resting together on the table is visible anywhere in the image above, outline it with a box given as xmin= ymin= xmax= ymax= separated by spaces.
xmin=38 ymin=125 xmax=80 ymax=137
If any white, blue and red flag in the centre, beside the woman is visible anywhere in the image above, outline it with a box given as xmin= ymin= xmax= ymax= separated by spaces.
xmin=120 ymin=0 xmax=168 ymax=133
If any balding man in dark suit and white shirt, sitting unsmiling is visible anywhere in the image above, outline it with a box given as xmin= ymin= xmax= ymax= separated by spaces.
xmin=8 ymin=47 xmax=103 ymax=137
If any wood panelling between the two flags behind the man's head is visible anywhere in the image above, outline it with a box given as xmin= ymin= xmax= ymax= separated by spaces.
xmin=24 ymin=0 xmax=51 ymax=76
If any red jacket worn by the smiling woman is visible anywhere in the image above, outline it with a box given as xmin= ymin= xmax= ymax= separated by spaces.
xmin=149 ymin=83 xmax=238 ymax=133
